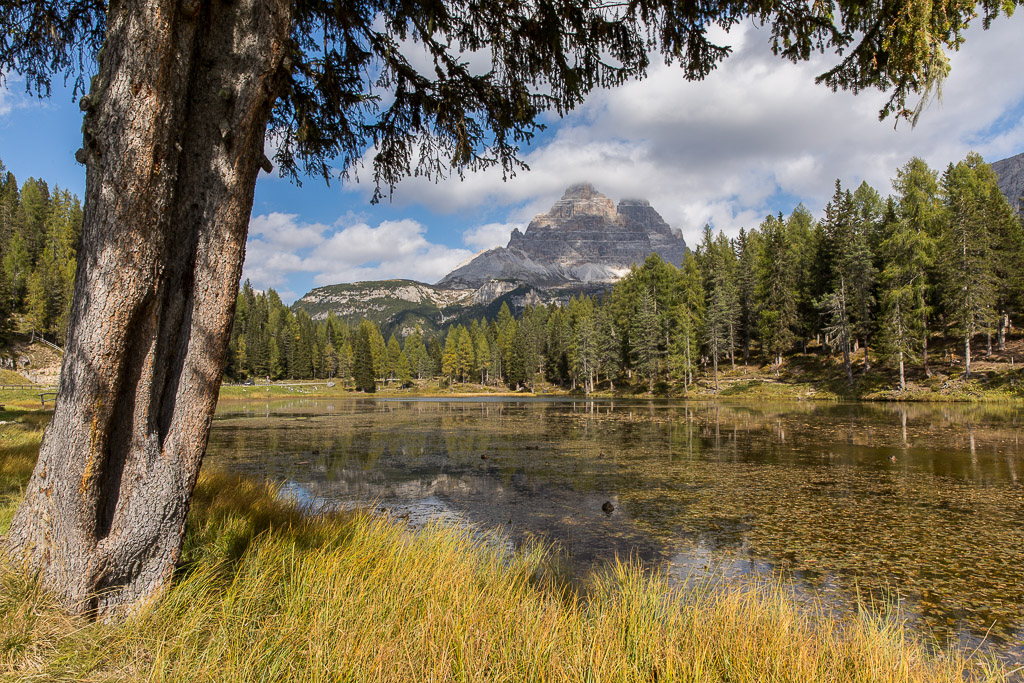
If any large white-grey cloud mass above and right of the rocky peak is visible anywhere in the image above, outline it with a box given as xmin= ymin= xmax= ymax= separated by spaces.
xmin=349 ymin=13 xmax=1024 ymax=248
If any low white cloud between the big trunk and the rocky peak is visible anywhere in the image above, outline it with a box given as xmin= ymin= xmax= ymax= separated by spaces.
xmin=243 ymin=213 xmax=473 ymax=300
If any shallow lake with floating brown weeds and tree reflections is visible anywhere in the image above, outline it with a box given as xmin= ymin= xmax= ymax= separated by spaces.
xmin=208 ymin=398 xmax=1024 ymax=665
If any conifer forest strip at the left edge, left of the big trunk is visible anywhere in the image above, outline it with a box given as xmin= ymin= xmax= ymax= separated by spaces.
xmin=0 ymin=161 xmax=82 ymax=343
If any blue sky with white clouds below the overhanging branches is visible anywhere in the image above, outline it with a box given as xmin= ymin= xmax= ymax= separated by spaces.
xmin=0 ymin=12 xmax=1024 ymax=301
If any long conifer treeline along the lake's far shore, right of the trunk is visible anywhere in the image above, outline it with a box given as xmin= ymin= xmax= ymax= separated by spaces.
xmin=229 ymin=154 xmax=1024 ymax=392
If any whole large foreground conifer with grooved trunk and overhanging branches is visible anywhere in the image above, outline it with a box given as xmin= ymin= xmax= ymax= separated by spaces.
xmin=6 ymin=0 xmax=1019 ymax=615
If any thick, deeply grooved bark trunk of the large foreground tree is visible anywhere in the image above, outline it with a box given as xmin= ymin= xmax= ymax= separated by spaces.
xmin=8 ymin=0 xmax=291 ymax=617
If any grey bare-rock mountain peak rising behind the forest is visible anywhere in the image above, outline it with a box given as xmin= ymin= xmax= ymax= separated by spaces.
xmin=437 ymin=184 xmax=686 ymax=289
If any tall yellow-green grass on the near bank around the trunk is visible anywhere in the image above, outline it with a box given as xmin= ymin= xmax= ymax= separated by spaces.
xmin=0 ymin=423 xmax=1007 ymax=683
